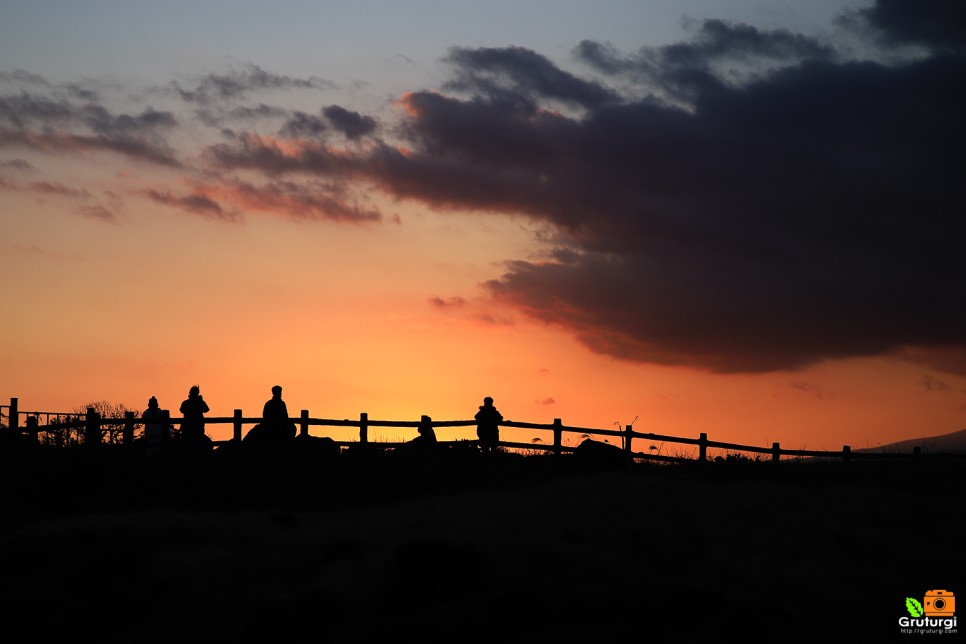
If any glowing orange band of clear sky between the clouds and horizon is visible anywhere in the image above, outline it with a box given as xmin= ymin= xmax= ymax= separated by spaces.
xmin=0 ymin=158 xmax=966 ymax=450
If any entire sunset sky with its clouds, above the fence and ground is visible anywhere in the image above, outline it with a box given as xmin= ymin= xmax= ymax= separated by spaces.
xmin=0 ymin=0 xmax=966 ymax=449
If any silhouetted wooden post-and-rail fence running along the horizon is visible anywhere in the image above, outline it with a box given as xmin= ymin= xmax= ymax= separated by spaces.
xmin=0 ymin=398 xmax=952 ymax=462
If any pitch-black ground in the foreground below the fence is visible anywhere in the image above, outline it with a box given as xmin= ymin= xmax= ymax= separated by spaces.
xmin=0 ymin=452 xmax=966 ymax=643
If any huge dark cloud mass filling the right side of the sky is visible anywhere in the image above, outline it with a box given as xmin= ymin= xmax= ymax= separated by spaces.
xmin=366 ymin=3 xmax=966 ymax=372
